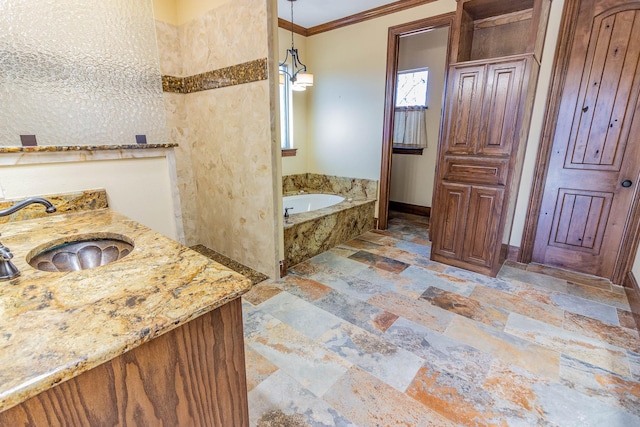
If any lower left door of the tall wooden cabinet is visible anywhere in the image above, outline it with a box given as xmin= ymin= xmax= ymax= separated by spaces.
xmin=432 ymin=183 xmax=471 ymax=259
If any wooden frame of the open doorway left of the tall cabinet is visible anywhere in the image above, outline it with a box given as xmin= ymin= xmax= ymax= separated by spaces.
xmin=378 ymin=12 xmax=456 ymax=230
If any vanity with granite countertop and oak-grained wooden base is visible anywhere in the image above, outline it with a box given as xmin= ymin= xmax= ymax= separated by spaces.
xmin=0 ymin=209 xmax=251 ymax=426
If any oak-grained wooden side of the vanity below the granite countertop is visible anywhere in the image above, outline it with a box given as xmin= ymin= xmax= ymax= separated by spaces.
xmin=0 ymin=298 xmax=249 ymax=427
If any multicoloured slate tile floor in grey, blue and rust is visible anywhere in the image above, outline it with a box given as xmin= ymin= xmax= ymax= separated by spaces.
xmin=243 ymin=214 xmax=640 ymax=427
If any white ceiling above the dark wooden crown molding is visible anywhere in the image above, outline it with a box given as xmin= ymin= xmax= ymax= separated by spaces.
xmin=278 ymin=0 xmax=397 ymax=28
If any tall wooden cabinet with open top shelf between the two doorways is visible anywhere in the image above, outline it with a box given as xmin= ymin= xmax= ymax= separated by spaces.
xmin=431 ymin=0 xmax=550 ymax=276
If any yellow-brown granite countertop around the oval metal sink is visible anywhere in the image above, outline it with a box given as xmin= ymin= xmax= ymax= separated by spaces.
xmin=0 ymin=209 xmax=251 ymax=412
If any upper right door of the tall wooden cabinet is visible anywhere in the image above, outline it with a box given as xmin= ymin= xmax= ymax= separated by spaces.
xmin=476 ymin=59 xmax=527 ymax=156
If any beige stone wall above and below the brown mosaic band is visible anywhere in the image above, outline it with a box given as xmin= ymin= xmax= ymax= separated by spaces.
xmin=157 ymin=0 xmax=282 ymax=277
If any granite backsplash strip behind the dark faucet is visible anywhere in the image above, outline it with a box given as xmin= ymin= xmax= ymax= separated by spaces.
xmin=0 ymin=190 xmax=109 ymax=224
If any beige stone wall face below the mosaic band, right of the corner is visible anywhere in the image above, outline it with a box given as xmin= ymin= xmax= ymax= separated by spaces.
xmin=186 ymin=81 xmax=276 ymax=275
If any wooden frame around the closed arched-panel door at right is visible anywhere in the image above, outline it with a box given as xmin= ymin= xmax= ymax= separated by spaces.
xmin=518 ymin=0 xmax=640 ymax=284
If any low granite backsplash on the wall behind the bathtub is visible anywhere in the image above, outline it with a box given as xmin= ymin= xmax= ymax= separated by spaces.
xmin=282 ymin=173 xmax=378 ymax=200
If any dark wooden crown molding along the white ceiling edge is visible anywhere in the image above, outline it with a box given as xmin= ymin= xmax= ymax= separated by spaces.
xmin=278 ymin=0 xmax=436 ymax=37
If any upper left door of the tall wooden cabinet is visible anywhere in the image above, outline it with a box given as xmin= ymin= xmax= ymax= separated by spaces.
xmin=443 ymin=65 xmax=485 ymax=154
